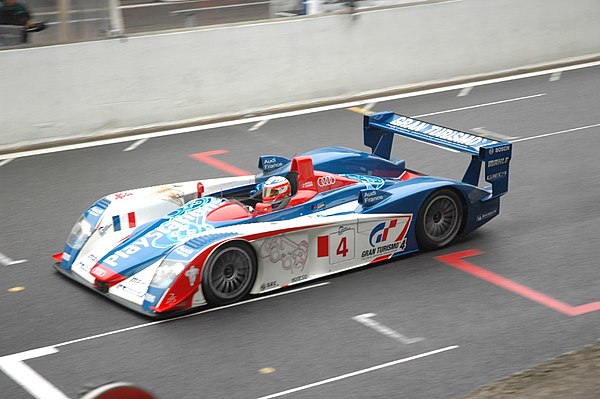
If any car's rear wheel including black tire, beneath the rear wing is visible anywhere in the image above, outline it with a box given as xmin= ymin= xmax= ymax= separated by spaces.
xmin=417 ymin=188 xmax=464 ymax=251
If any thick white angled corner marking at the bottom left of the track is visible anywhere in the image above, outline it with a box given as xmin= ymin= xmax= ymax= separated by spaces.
xmin=0 ymin=346 xmax=69 ymax=399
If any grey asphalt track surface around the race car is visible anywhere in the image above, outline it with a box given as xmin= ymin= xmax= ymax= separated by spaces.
xmin=0 ymin=67 xmax=600 ymax=399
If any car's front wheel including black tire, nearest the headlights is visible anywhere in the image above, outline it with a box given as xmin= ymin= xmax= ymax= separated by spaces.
xmin=202 ymin=242 xmax=257 ymax=306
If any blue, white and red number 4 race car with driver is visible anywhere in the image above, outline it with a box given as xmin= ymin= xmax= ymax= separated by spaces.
xmin=54 ymin=112 xmax=512 ymax=317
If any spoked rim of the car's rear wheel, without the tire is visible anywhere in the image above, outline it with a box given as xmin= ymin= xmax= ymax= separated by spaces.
xmin=425 ymin=195 xmax=458 ymax=243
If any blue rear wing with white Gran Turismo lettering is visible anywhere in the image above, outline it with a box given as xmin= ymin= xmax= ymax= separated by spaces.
xmin=363 ymin=112 xmax=512 ymax=197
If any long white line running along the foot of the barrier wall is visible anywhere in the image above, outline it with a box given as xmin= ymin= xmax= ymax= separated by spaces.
xmin=0 ymin=58 xmax=600 ymax=160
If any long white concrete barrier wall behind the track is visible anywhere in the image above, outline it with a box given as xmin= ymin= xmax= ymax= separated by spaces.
xmin=0 ymin=0 xmax=600 ymax=148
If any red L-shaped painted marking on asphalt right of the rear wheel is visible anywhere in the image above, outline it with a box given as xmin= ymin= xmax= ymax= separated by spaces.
xmin=436 ymin=249 xmax=600 ymax=316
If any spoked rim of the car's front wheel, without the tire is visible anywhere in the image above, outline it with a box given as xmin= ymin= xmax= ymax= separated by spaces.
xmin=208 ymin=247 xmax=252 ymax=299
